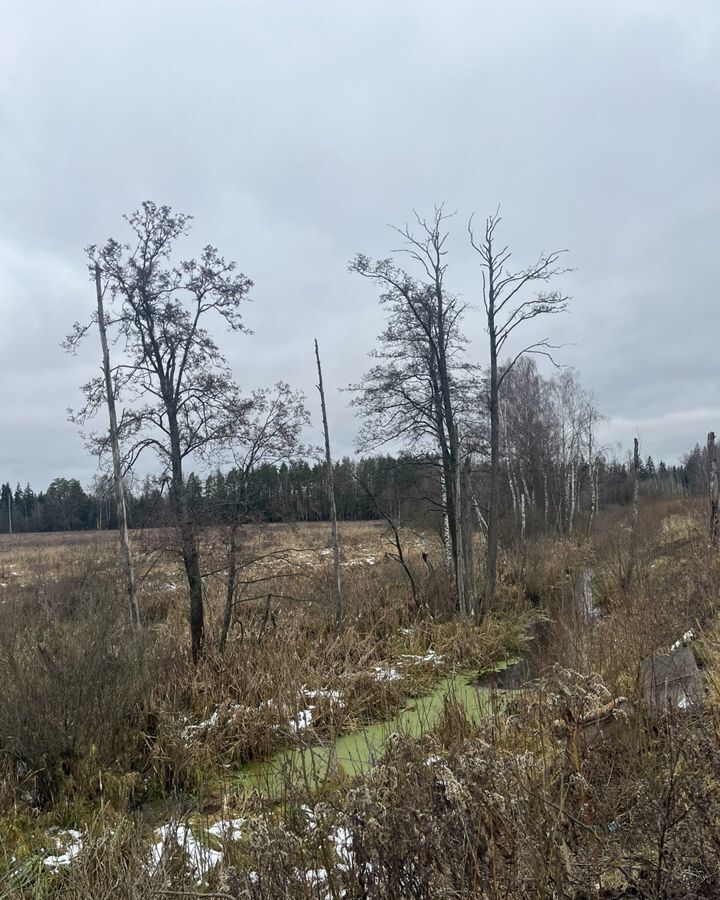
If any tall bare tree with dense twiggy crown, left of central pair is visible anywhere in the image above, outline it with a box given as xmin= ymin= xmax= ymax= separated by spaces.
xmin=350 ymin=207 xmax=476 ymax=615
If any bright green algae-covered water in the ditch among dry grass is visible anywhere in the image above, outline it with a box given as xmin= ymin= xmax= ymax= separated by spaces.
xmin=237 ymin=673 xmax=497 ymax=797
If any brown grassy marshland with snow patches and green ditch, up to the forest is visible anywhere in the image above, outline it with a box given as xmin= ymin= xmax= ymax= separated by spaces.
xmin=0 ymin=501 xmax=720 ymax=900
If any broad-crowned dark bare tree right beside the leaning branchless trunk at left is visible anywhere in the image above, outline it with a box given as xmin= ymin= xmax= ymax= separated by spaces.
xmin=69 ymin=202 xmax=252 ymax=660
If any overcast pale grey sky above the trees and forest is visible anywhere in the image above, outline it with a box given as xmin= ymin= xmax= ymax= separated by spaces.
xmin=0 ymin=0 xmax=720 ymax=487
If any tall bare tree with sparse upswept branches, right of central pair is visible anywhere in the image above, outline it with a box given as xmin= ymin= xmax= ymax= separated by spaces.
xmin=468 ymin=213 xmax=568 ymax=609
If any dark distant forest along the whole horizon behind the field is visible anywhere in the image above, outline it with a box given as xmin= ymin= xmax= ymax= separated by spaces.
xmin=0 ymin=445 xmax=707 ymax=534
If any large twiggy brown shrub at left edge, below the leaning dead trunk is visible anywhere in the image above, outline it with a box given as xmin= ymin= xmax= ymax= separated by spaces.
xmin=0 ymin=572 xmax=158 ymax=804
